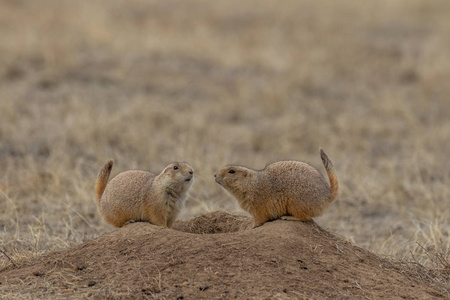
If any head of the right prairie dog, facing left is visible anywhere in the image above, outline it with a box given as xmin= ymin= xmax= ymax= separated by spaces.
xmin=214 ymin=165 xmax=257 ymax=201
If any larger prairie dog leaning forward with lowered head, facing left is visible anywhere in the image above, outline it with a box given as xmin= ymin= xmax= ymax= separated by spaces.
xmin=214 ymin=149 xmax=339 ymax=227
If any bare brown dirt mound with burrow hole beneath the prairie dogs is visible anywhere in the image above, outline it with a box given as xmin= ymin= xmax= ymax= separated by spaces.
xmin=0 ymin=212 xmax=444 ymax=299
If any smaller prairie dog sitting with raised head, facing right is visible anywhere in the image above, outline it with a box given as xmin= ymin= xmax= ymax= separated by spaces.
xmin=95 ymin=160 xmax=194 ymax=227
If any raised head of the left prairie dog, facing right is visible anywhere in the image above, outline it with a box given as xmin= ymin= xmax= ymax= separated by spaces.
xmin=158 ymin=162 xmax=194 ymax=193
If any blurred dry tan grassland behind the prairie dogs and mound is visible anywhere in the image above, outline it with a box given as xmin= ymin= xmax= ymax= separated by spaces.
xmin=0 ymin=0 xmax=450 ymax=282
